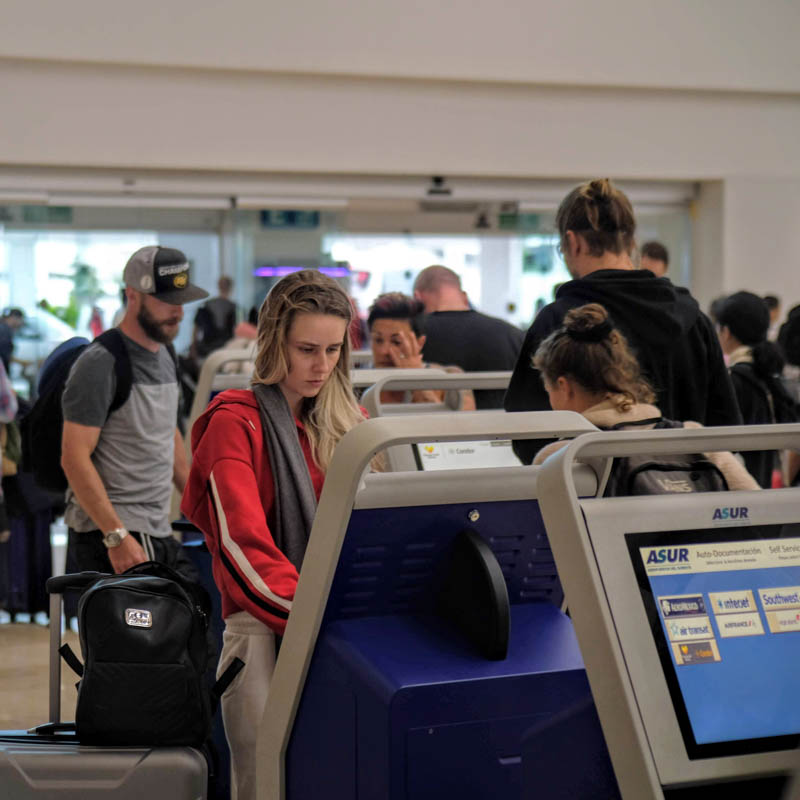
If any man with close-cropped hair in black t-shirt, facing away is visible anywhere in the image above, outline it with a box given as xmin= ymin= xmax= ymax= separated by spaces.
xmin=414 ymin=265 xmax=525 ymax=410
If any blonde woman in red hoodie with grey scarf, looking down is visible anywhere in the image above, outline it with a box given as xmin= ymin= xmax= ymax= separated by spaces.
xmin=181 ymin=270 xmax=363 ymax=800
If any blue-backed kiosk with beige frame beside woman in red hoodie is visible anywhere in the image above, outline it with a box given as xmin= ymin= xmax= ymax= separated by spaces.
xmin=257 ymin=412 xmax=607 ymax=800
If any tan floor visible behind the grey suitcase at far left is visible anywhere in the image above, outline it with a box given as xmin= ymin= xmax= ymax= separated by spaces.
xmin=0 ymin=624 xmax=80 ymax=730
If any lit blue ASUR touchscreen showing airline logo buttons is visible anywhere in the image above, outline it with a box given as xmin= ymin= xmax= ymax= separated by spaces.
xmin=625 ymin=524 xmax=800 ymax=758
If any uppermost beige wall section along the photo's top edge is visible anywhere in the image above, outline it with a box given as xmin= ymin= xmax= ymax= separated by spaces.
xmin=0 ymin=0 xmax=800 ymax=92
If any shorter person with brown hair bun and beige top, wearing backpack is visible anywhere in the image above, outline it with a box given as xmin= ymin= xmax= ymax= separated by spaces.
xmin=533 ymin=303 xmax=759 ymax=489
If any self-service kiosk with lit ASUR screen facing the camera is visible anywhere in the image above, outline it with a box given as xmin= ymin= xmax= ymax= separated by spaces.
xmin=536 ymin=425 xmax=800 ymax=800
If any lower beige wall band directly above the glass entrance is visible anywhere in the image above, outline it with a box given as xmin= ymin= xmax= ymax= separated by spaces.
xmin=0 ymin=61 xmax=800 ymax=180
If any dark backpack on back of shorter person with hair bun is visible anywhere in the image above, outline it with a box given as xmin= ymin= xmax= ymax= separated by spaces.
xmin=603 ymin=417 xmax=728 ymax=497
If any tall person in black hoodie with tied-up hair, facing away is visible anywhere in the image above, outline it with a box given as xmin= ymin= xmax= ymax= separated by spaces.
xmin=504 ymin=178 xmax=741 ymax=463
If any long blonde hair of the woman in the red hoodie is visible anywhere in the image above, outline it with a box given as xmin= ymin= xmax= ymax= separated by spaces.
xmin=253 ymin=269 xmax=364 ymax=472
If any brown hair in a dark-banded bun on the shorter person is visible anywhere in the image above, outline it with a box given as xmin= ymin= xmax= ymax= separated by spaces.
xmin=533 ymin=303 xmax=655 ymax=411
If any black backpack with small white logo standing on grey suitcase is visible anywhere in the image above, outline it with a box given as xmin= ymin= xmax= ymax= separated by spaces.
xmin=51 ymin=561 xmax=244 ymax=746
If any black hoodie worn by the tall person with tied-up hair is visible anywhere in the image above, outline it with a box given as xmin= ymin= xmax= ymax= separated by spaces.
xmin=504 ymin=269 xmax=742 ymax=464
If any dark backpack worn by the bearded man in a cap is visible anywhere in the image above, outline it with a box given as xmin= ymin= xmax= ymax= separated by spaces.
xmin=20 ymin=328 xmax=180 ymax=494
